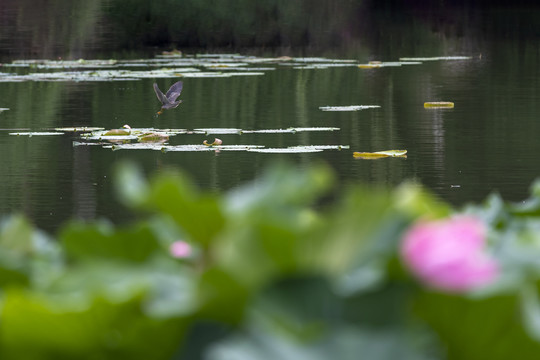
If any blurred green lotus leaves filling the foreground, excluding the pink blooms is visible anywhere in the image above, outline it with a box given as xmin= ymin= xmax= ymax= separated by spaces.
xmin=0 ymin=165 xmax=540 ymax=360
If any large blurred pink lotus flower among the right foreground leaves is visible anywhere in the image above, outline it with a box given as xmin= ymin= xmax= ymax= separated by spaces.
xmin=401 ymin=216 xmax=499 ymax=292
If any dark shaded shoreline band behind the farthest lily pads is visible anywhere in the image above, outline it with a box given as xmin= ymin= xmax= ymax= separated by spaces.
xmin=0 ymin=0 xmax=540 ymax=60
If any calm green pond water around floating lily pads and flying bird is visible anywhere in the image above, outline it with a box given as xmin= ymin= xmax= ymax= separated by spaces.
xmin=0 ymin=7 xmax=540 ymax=236
